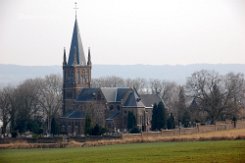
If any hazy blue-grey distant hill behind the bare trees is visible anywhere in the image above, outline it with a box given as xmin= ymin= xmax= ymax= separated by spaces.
xmin=0 ymin=64 xmax=245 ymax=87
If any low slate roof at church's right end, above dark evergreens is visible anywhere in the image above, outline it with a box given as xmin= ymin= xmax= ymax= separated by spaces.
xmin=140 ymin=94 xmax=163 ymax=107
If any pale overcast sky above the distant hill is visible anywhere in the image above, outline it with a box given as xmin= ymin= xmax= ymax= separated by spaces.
xmin=0 ymin=0 xmax=245 ymax=65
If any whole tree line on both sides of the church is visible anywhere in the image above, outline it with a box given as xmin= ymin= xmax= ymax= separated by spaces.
xmin=0 ymin=70 xmax=245 ymax=135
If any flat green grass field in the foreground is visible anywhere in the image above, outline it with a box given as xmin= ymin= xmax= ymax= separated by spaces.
xmin=0 ymin=140 xmax=245 ymax=163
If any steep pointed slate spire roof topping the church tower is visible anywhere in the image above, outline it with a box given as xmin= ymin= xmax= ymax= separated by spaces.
xmin=68 ymin=19 xmax=86 ymax=66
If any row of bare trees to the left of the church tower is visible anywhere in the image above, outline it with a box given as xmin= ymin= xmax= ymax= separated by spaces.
xmin=0 ymin=75 xmax=62 ymax=135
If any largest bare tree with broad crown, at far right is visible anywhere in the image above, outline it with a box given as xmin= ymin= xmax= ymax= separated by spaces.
xmin=186 ymin=70 xmax=244 ymax=123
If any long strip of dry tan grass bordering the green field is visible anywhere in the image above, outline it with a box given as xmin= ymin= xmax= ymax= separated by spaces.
xmin=0 ymin=129 xmax=245 ymax=149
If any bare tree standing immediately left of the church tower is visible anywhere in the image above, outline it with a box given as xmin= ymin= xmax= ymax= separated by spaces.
xmin=38 ymin=75 xmax=62 ymax=134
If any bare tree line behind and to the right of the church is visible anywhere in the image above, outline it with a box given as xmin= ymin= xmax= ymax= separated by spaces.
xmin=92 ymin=70 xmax=245 ymax=127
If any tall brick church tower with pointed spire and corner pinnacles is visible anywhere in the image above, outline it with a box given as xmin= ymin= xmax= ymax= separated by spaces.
xmin=63 ymin=16 xmax=92 ymax=115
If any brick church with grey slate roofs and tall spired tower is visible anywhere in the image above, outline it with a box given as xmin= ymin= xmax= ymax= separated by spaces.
xmin=61 ymin=16 xmax=162 ymax=136
